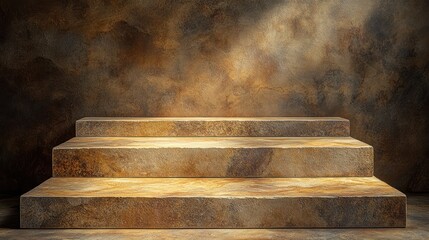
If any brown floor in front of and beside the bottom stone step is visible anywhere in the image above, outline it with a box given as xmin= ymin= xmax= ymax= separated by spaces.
xmin=0 ymin=194 xmax=429 ymax=240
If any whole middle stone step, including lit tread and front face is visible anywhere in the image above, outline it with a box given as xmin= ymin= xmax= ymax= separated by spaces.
xmin=52 ymin=137 xmax=373 ymax=177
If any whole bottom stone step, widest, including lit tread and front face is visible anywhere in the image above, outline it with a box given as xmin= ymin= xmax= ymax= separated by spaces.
xmin=21 ymin=177 xmax=406 ymax=228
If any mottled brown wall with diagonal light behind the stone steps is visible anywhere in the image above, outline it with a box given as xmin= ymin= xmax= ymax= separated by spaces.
xmin=0 ymin=0 xmax=429 ymax=192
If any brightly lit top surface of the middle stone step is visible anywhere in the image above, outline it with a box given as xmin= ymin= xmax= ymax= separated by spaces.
xmin=54 ymin=137 xmax=371 ymax=149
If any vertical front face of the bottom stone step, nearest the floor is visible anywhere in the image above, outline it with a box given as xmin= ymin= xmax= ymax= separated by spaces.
xmin=21 ymin=197 xmax=406 ymax=228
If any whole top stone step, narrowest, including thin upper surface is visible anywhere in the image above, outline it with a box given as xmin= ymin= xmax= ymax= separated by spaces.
xmin=76 ymin=117 xmax=350 ymax=137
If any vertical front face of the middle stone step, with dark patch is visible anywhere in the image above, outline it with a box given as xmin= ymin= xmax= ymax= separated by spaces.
xmin=53 ymin=147 xmax=373 ymax=177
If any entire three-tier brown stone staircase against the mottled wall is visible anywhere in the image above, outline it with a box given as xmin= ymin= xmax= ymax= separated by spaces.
xmin=20 ymin=117 xmax=406 ymax=228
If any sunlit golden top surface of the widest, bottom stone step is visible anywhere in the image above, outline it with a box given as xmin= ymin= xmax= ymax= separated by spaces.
xmin=22 ymin=177 xmax=405 ymax=198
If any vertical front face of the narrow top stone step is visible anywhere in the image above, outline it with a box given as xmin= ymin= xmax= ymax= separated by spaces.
xmin=76 ymin=119 xmax=350 ymax=137
